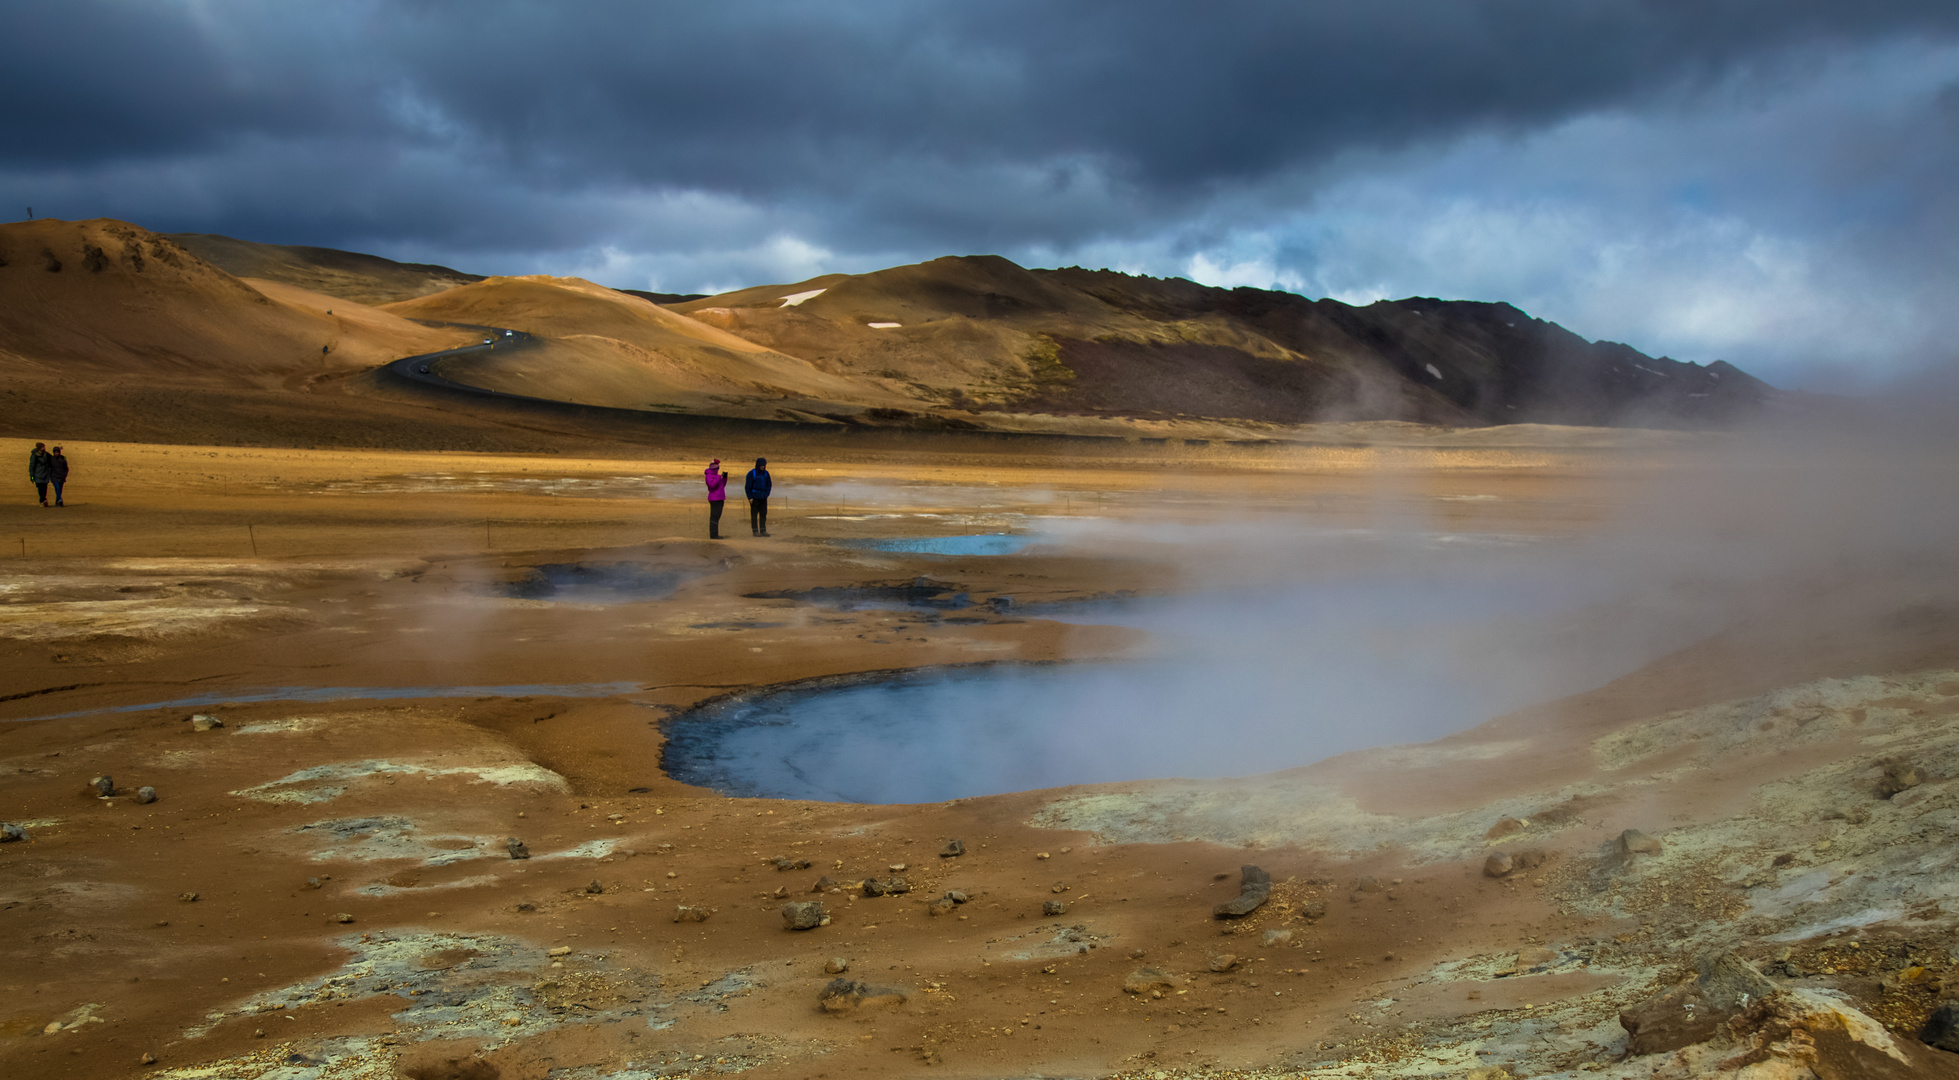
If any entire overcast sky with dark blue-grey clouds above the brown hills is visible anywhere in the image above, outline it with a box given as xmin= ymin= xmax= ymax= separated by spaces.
xmin=0 ymin=0 xmax=1959 ymax=388
